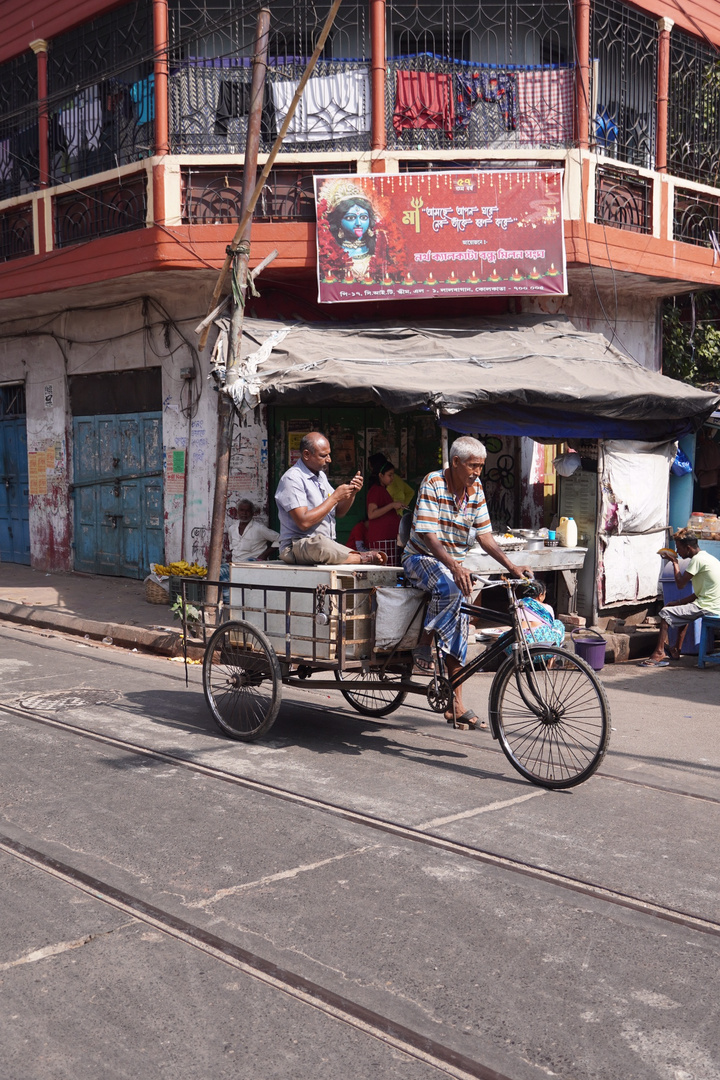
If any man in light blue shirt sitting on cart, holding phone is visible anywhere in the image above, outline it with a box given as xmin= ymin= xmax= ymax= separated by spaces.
xmin=275 ymin=431 xmax=388 ymax=566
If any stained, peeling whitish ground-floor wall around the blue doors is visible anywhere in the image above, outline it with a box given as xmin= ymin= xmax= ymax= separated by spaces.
xmin=0 ymin=294 xmax=268 ymax=570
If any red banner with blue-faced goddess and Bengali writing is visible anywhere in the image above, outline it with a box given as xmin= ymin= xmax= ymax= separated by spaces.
xmin=315 ymin=168 xmax=567 ymax=303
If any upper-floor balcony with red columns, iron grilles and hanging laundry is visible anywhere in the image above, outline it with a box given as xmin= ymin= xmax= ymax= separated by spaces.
xmin=0 ymin=0 xmax=720 ymax=295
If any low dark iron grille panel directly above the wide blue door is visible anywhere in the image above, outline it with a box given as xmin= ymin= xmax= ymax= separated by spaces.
xmin=53 ymin=173 xmax=147 ymax=247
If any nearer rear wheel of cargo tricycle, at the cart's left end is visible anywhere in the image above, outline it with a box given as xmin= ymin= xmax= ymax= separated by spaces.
xmin=203 ymin=621 xmax=282 ymax=740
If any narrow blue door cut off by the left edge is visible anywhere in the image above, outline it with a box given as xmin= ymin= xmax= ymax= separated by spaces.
xmin=0 ymin=386 xmax=30 ymax=566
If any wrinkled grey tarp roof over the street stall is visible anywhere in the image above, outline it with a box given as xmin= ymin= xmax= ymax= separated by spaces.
xmin=244 ymin=315 xmax=720 ymax=440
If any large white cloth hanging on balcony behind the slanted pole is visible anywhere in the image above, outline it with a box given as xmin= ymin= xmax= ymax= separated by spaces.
xmin=270 ymin=68 xmax=370 ymax=143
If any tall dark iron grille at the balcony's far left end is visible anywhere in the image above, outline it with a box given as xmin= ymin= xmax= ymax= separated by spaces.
xmin=0 ymin=53 xmax=39 ymax=199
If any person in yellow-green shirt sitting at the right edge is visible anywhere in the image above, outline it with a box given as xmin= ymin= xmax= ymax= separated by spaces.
xmin=640 ymin=529 xmax=720 ymax=667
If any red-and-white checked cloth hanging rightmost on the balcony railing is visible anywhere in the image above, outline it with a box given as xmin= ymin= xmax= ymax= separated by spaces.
xmin=517 ymin=67 xmax=575 ymax=146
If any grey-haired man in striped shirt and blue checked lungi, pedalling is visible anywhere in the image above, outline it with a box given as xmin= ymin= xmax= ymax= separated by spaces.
xmin=403 ymin=435 xmax=530 ymax=728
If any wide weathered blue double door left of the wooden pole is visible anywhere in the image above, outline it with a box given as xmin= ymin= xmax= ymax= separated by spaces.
xmin=72 ymin=413 xmax=164 ymax=578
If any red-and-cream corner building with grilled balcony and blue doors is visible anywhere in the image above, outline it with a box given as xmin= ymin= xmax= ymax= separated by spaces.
xmin=0 ymin=0 xmax=720 ymax=577
